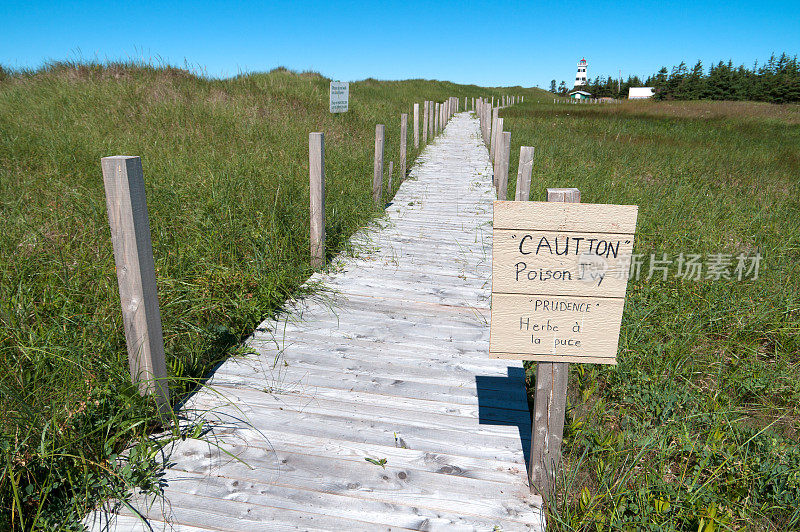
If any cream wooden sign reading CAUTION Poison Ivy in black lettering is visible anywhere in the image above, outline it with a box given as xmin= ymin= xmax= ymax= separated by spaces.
xmin=489 ymin=201 xmax=638 ymax=364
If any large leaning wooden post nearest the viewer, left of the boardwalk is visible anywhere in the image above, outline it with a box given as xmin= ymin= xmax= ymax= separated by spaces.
xmin=100 ymin=155 xmax=171 ymax=421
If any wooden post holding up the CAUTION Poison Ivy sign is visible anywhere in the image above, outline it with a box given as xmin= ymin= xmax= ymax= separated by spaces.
xmin=528 ymin=188 xmax=581 ymax=499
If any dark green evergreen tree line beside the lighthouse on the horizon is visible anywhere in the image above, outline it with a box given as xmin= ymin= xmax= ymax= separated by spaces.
xmin=550 ymin=53 xmax=800 ymax=103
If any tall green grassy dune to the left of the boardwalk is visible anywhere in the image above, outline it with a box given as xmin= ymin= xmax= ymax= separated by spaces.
xmin=0 ymin=64 xmax=535 ymax=530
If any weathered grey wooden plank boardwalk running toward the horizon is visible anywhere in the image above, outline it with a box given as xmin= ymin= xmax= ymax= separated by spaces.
xmin=94 ymin=113 xmax=542 ymax=531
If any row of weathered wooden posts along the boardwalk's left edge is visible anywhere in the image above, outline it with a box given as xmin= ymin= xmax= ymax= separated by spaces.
xmin=101 ymin=96 xmax=517 ymax=421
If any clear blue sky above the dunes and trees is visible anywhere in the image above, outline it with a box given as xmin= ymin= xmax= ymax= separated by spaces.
xmin=0 ymin=0 xmax=800 ymax=87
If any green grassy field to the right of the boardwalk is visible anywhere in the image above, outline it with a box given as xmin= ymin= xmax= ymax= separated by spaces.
xmin=501 ymin=98 xmax=800 ymax=531
